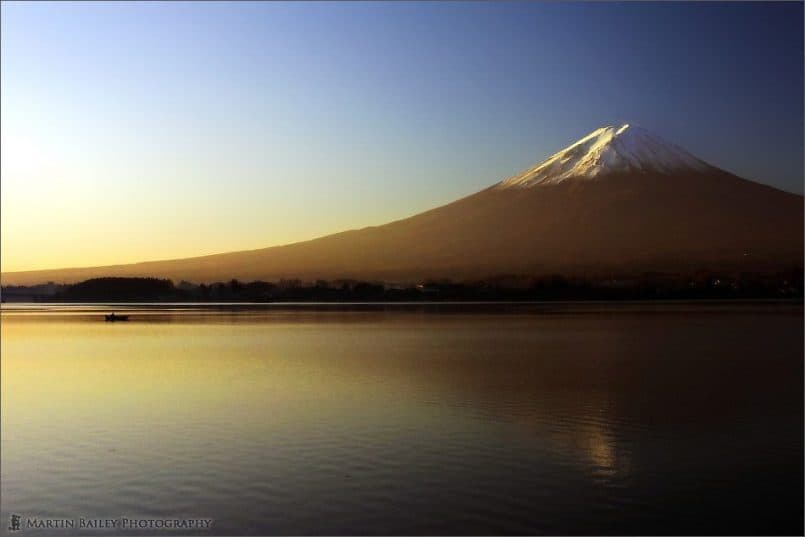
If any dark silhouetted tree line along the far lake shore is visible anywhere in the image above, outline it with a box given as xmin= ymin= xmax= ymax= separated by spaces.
xmin=1 ymin=268 xmax=803 ymax=302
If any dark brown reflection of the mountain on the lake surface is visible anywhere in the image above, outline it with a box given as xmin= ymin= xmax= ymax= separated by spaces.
xmin=316 ymin=304 xmax=802 ymax=481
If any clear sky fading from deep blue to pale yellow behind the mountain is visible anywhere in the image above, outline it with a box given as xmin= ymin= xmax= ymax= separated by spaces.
xmin=0 ymin=1 xmax=803 ymax=271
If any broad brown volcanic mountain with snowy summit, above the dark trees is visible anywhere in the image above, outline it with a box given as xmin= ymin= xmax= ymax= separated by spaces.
xmin=3 ymin=125 xmax=803 ymax=285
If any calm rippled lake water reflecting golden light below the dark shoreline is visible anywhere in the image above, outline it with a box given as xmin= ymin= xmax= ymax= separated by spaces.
xmin=0 ymin=304 xmax=803 ymax=535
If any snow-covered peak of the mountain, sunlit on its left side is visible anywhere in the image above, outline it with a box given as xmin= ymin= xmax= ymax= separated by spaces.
xmin=499 ymin=124 xmax=711 ymax=188
